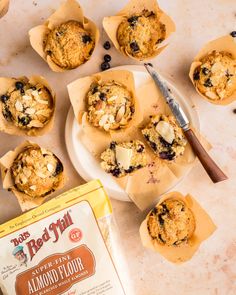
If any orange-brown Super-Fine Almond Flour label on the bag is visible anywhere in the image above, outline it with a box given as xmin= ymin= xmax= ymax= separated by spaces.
xmin=15 ymin=245 xmax=96 ymax=295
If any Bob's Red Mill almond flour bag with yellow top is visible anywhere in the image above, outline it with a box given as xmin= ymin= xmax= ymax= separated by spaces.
xmin=0 ymin=181 xmax=134 ymax=295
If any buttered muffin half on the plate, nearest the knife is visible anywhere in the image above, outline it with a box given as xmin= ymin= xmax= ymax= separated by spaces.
xmin=142 ymin=115 xmax=187 ymax=161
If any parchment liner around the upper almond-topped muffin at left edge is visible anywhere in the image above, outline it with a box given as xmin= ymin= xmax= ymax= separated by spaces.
xmin=0 ymin=76 xmax=56 ymax=136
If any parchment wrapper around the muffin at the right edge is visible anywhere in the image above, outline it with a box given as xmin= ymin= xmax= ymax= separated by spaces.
xmin=189 ymin=35 xmax=236 ymax=105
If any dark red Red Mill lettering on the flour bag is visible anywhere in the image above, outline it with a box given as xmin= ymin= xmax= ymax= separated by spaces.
xmin=26 ymin=212 xmax=73 ymax=260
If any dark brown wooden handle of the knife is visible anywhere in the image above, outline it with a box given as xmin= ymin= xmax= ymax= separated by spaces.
xmin=184 ymin=129 xmax=228 ymax=183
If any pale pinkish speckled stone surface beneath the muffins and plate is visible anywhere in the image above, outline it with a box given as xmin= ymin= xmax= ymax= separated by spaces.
xmin=0 ymin=0 xmax=236 ymax=295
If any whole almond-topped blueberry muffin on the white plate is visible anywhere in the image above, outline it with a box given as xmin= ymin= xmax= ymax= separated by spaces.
xmin=87 ymin=81 xmax=134 ymax=131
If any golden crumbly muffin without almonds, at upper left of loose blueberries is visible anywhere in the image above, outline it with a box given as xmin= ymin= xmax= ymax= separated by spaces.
xmin=44 ymin=20 xmax=95 ymax=70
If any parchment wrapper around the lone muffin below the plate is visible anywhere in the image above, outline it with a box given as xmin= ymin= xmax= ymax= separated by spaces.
xmin=139 ymin=192 xmax=216 ymax=264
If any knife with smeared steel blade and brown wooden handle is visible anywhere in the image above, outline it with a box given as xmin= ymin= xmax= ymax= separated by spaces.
xmin=144 ymin=63 xmax=228 ymax=183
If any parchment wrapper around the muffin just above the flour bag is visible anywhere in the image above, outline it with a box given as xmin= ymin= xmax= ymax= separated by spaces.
xmin=0 ymin=141 xmax=66 ymax=211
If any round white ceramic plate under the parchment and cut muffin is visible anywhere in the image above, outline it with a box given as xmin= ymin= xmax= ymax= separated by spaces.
xmin=65 ymin=66 xmax=199 ymax=201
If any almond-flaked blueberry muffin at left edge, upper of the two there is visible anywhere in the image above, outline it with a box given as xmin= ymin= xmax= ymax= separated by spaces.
xmin=0 ymin=78 xmax=54 ymax=130
